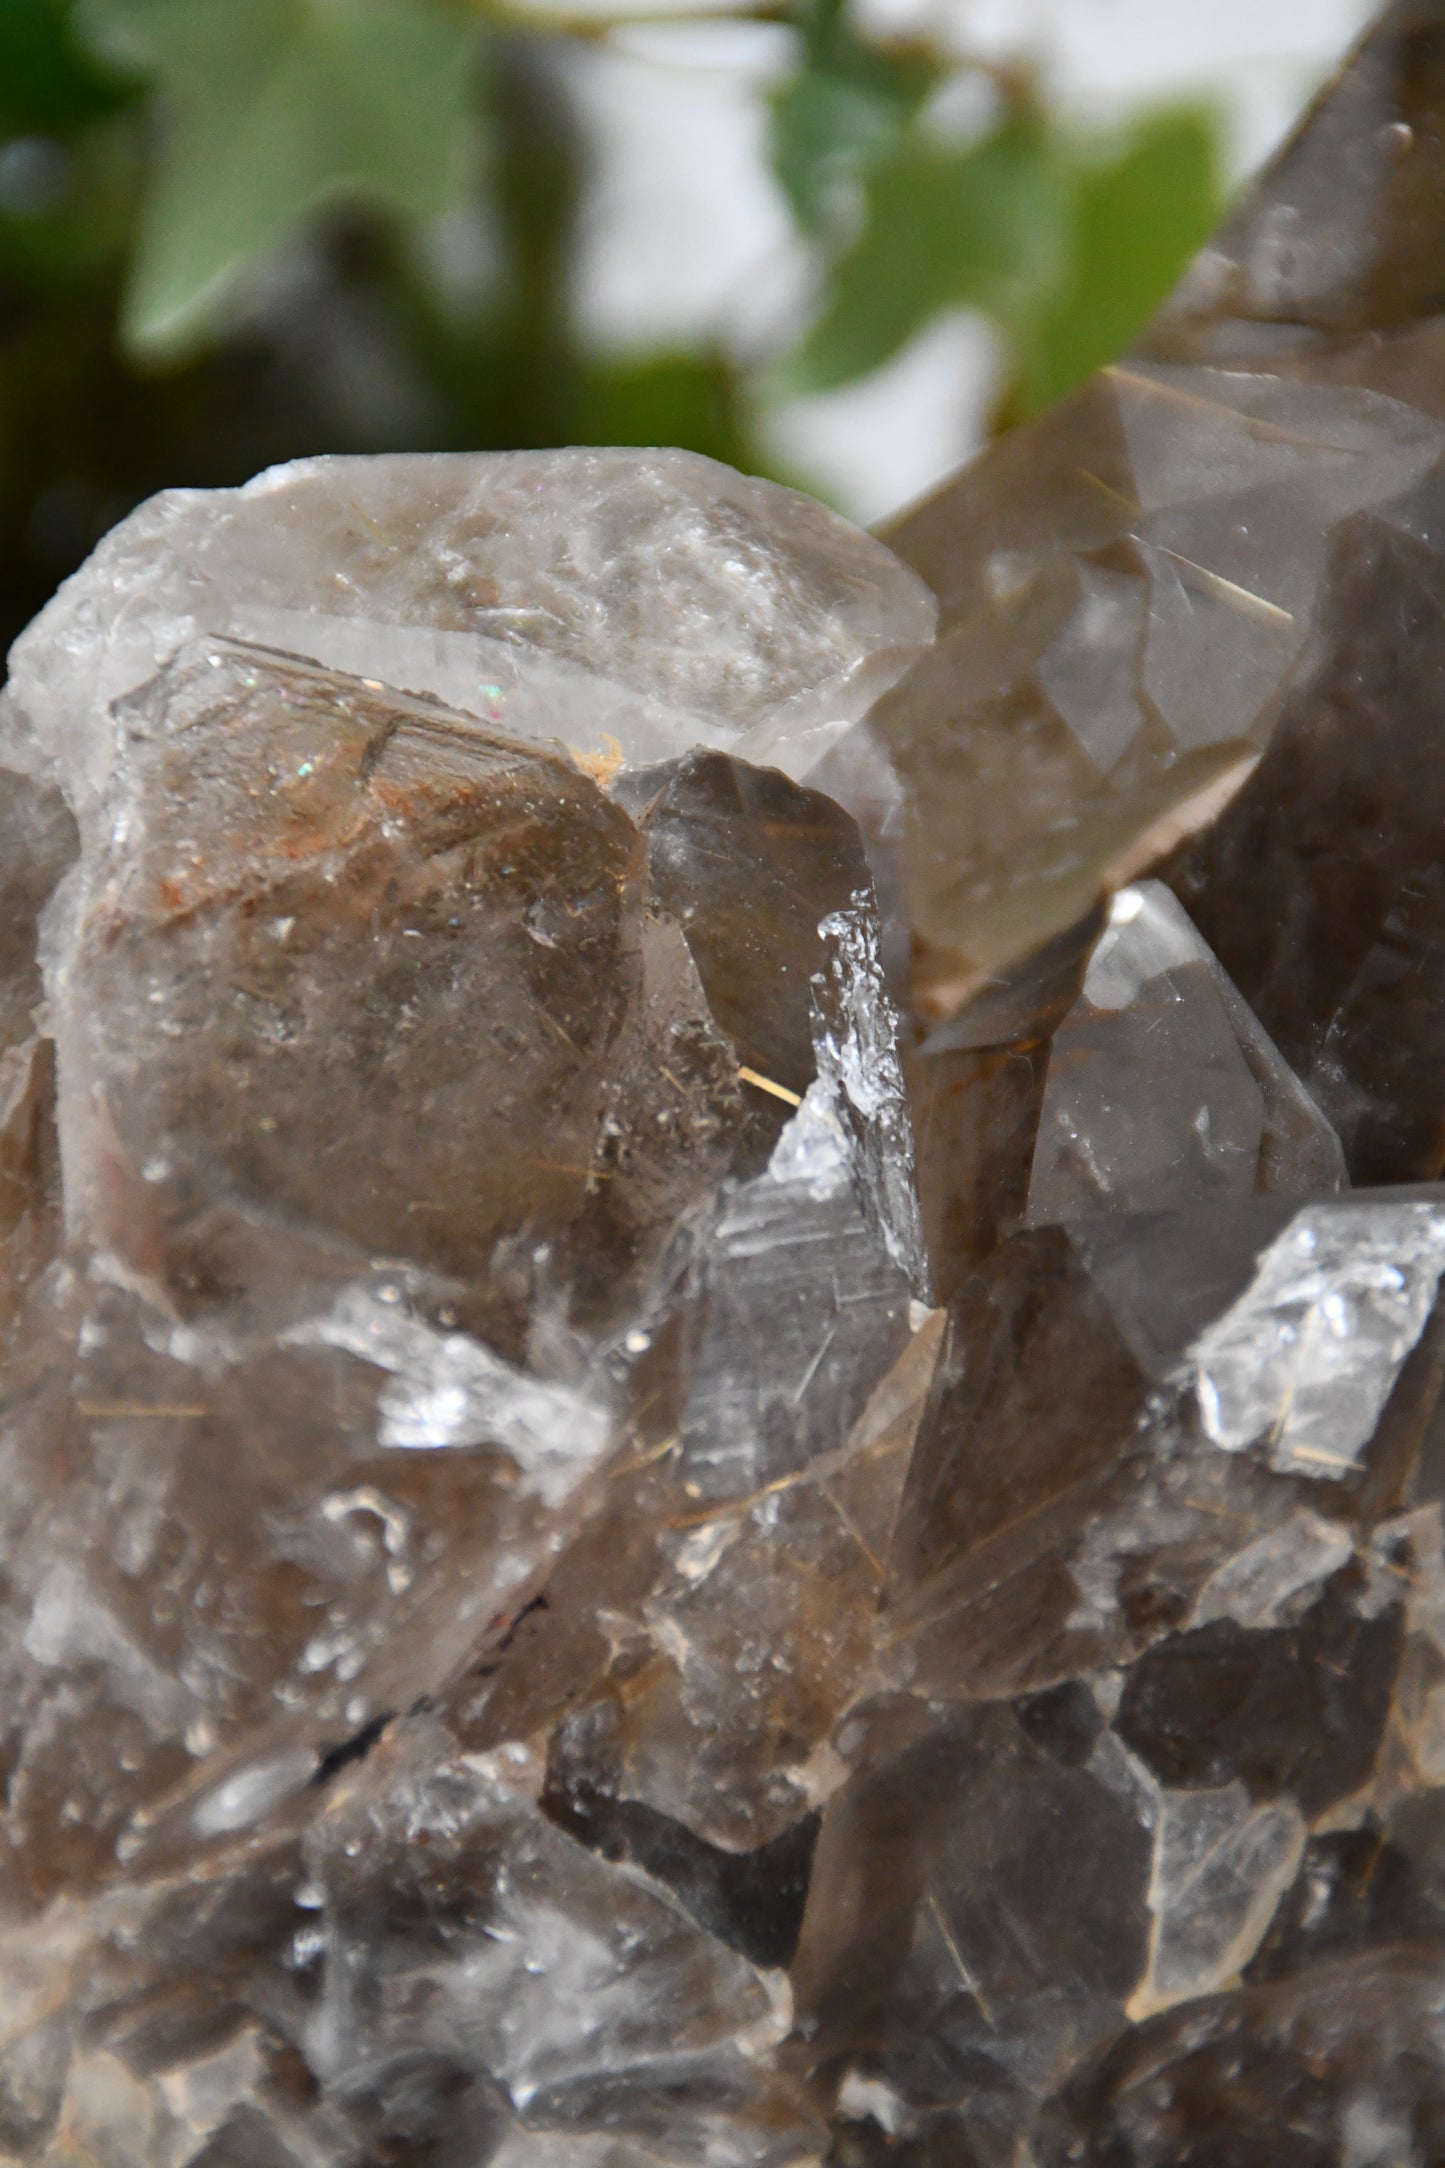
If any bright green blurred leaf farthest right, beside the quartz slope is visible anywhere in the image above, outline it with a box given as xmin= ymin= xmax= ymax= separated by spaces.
xmin=1007 ymin=106 xmax=1220 ymax=421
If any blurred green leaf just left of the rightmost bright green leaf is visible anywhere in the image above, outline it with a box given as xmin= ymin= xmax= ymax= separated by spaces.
xmin=789 ymin=119 xmax=1070 ymax=390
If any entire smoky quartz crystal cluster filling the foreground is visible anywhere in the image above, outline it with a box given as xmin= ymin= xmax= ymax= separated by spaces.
xmin=0 ymin=0 xmax=1445 ymax=2168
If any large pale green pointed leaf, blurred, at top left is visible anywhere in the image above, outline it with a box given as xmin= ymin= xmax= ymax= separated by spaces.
xmin=78 ymin=0 xmax=474 ymax=356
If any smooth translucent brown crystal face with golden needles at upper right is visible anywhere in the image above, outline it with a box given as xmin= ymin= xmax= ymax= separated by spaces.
xmin=875 ymin=360 xmax=1445 ymax=1019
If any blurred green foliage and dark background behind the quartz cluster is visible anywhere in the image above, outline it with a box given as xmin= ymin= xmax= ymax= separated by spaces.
xmin=0 ymin=0 xmax=1218 ymax=640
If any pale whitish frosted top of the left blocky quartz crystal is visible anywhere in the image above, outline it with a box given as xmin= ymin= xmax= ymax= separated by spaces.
xmin=9 ymin=451 xmax=936 ymax=823
